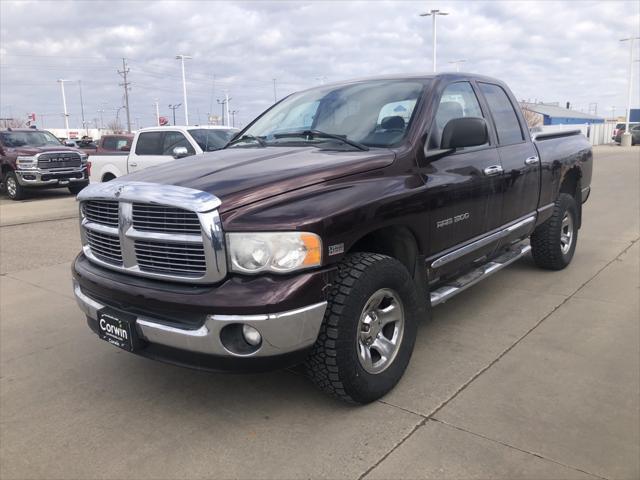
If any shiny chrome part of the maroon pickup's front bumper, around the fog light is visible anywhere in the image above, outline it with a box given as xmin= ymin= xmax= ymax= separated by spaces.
xmin=73 ymin=280 xmax=327 ymax=358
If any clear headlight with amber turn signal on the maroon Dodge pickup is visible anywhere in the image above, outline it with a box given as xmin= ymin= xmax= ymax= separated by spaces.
xmin=227 ymin=232 xmax=322 ymax=273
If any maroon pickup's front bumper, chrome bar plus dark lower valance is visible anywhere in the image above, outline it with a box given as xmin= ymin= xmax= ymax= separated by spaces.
xmin=73 ymin=280 xmax=327 ymax=370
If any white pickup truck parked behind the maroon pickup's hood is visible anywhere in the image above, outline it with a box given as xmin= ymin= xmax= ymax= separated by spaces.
xmin=90 ymin=125 xmax=239 ymax=183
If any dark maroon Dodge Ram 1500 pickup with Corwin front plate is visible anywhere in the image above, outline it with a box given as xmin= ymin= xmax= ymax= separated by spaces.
xmin=73 ymin=74 xmax=592 ymax=403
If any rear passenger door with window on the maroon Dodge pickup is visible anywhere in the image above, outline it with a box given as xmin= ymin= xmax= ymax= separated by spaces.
xmin=478 ymin=82 xmax=540 ymax=224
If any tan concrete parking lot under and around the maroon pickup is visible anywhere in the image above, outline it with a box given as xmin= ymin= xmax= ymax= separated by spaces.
xmin=0 ymin=146 xmax=640 ymax=479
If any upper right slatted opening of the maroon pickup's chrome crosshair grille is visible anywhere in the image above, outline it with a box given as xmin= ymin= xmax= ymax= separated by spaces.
xmin=133 ymin=203 xmax=200 ymax=235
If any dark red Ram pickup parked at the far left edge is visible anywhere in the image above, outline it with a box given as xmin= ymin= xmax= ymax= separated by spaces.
xmin=0 ymin=128 xmax=89 ymax=200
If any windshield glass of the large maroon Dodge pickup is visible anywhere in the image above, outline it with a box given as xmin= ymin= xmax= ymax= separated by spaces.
xmin=234 ymin=79 xmax=429 ymax=147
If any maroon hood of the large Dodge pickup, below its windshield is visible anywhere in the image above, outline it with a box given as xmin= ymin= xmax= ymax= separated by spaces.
xmin=122 ymin=147 xmax=395 ymax=212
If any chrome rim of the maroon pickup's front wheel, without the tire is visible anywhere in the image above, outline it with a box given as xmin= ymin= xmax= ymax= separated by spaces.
xmin=356 ymin=288 xmax=404 ymax=375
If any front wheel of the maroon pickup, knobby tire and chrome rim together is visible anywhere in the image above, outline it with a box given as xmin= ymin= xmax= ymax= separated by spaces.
xmin=305 ymin=253 xmax=420 ymax=403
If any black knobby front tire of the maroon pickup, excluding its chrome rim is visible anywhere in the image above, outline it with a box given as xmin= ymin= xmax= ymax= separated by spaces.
xmin=304 ymin=253 xmax=421 ymax=404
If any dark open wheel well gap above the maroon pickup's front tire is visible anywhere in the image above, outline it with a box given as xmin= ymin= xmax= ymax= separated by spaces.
xmin=349 ymin=226 xmax=418 ymax=276
